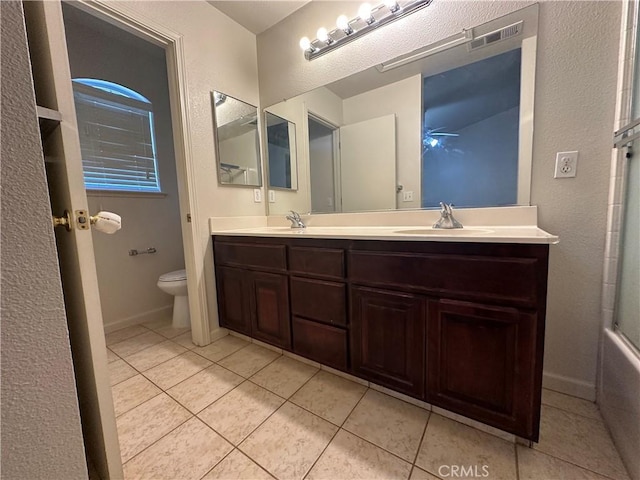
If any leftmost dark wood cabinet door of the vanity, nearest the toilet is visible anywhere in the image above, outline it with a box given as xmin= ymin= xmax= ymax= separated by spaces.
xmin=216 ymin=267 xmax=251 ymax=335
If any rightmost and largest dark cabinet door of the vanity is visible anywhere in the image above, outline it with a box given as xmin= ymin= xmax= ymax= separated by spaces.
xmin=427 ymin=300 xmax=542 ymax=441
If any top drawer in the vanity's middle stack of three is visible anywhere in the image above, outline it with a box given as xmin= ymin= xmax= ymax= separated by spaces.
xmin=289 ymin=247 xmax=344 ymax=279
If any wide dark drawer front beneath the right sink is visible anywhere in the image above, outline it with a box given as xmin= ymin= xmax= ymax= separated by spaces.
xmin=349 ymin=251 xmax=544 ymax=306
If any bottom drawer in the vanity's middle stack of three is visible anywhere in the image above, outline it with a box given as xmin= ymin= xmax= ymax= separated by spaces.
xmin=293 ymin=317 xmax=347 ymax=370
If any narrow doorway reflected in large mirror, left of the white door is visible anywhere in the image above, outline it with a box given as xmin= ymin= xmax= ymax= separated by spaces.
xmin=308 ymin=115 xmax=342 ymax=213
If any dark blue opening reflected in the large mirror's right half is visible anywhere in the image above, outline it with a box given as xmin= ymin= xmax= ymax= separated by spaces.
xmin=421 ymin=49 xmax=521 ymax=208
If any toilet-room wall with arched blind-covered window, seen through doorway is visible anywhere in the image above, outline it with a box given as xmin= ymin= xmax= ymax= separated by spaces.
xmin=62 ymin=3 xmax=184 ymax=333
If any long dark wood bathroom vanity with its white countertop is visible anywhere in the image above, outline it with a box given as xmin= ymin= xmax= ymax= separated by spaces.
xmin=213 ymin=228 xmax=557 ymax=441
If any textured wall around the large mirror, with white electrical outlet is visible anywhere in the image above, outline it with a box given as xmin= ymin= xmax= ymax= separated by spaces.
xmin=258 ymin=1 xmax=621 ymax=397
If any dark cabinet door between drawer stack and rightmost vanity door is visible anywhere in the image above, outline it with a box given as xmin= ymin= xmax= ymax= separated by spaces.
xmin=351 ymin=287 xmax=426 ymax=399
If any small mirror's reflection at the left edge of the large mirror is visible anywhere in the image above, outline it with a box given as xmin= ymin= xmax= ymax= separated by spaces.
xmin=264 ymin=111 xmax=298 ymax=190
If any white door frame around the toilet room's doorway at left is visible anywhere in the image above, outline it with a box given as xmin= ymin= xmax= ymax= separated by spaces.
xmin=72 ymin=0 xmax=211 ymax=346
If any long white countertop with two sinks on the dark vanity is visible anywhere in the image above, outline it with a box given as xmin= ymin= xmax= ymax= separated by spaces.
xmin=211 ymin=224 xmax=559 ymax=244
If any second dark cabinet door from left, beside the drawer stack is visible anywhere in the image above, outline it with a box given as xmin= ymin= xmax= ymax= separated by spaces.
xmin=248 ymin=272 xmax=291 ymax=350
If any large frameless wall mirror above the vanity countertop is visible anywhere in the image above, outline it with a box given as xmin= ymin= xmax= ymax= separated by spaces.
xmin=269 ymin=5 xmax=538 ymax=215
